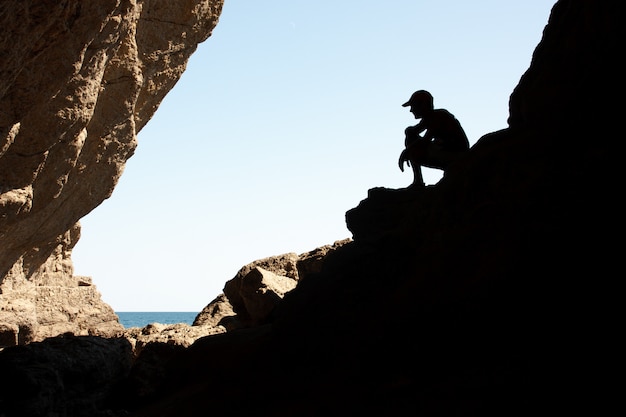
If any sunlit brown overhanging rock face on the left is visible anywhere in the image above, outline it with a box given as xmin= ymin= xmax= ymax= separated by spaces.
xmin=0 ymin=0 xmax=223 ymax=345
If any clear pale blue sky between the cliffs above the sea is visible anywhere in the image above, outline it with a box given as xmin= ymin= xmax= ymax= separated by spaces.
xmin=72 ymin=0 xmax=555 ymax=311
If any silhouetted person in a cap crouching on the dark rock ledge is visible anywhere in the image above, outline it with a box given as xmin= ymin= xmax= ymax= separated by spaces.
xmin=398 ymin=90 xmax=469 ymax=188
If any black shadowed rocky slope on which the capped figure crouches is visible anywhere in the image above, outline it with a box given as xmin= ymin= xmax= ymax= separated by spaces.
xmin=0 ymin=0 xmax=624 ymax=417
